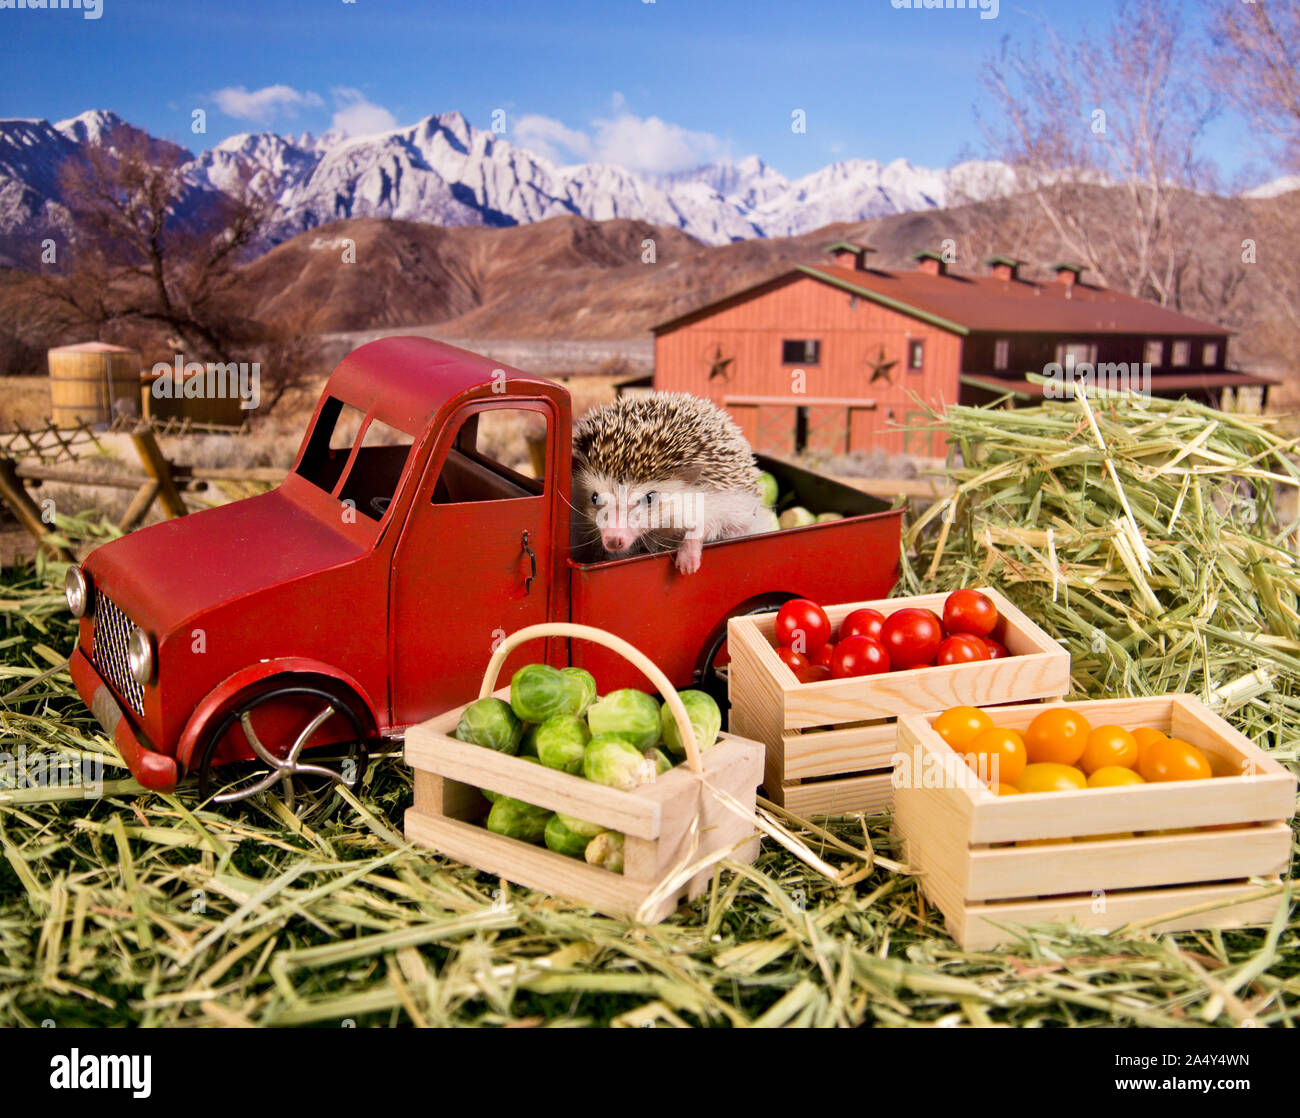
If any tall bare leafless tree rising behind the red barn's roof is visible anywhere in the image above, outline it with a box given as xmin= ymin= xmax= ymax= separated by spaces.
xmin=980 ymin=0 xmax=1216 ymax=306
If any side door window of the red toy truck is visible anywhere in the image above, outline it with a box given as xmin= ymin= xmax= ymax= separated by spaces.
xmin=433 ymin=407 xmax=549 ymax=504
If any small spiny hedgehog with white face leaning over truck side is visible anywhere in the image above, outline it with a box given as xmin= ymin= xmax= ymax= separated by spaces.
xmin=573 ymin=393 xmax=768 ymax=575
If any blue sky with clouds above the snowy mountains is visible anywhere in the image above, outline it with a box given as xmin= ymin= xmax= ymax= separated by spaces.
xmin=0 ymin=0 xmax=1271 ymax=179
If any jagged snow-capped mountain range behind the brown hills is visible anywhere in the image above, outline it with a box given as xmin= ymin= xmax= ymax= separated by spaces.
xmin=0 ymin=111 xmax=1011 ymax=259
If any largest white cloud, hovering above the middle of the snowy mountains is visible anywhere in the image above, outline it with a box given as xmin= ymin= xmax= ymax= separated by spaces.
xmin=515 ymin=94 xmax=725 ymax=172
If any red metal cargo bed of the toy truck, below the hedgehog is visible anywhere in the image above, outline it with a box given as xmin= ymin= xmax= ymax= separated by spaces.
xmin=569 ymin=455 xmax=902 ymax=692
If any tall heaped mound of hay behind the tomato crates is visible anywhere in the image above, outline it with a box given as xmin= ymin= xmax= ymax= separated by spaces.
xmin=900 ymin=399 xmax=1300 ymax=761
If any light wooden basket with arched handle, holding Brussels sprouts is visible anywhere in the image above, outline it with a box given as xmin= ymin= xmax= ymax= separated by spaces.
xmin=406 ymin=623 xmax=763 ymax=923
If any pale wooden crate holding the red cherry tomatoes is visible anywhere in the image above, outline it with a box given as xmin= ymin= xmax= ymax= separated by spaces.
xmin=727 ymin=588 xmax=1070 ymax=815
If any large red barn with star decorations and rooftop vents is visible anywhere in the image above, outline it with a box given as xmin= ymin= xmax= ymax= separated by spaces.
xmin=654 ymin=242 xmax=1270 ymax=455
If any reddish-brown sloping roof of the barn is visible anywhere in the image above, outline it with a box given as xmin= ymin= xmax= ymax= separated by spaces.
xmin=654 ymin=264 xmax=1231 ymax=338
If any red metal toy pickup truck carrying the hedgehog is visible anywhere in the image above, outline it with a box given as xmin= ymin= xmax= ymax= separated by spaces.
xmin=68 ymin=338 xmax=901 ymax=801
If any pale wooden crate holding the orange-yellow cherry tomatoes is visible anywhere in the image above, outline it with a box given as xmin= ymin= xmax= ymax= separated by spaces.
xmin=894 ymin=696 xmax=1296 ymax=950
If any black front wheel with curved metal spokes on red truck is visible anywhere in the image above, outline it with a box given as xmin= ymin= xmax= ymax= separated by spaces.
xmin=198 ymin=684 xmax=372 ymax=818
